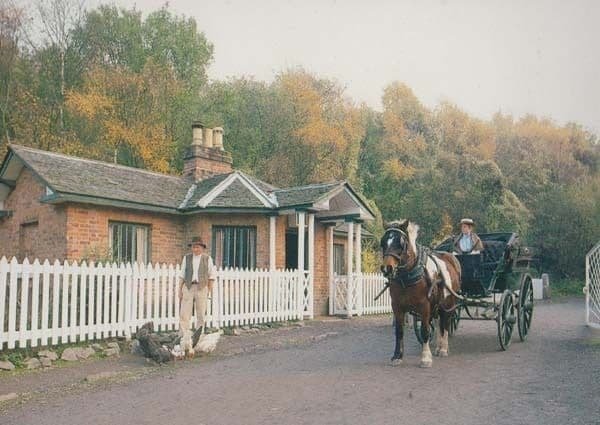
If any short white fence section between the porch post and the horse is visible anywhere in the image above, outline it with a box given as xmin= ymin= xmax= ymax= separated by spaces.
xmin=331 ymin=273 xmax=392 ymax=316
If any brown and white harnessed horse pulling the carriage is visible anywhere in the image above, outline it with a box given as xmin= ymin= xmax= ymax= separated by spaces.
xmin=381 ymin=219 xmax=461 ymax=367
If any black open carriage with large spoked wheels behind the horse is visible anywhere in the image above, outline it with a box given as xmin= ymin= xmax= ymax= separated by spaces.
xmin=426 ymin=233 xmax=539 ymax=350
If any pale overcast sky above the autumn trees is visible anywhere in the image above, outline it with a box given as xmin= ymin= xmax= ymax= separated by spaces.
xmin=96 ymin=0 xmax=600 ymax=134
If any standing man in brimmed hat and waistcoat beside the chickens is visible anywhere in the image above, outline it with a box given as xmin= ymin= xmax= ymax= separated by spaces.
xmin=179 ymin=236 xmax=216 ymax=335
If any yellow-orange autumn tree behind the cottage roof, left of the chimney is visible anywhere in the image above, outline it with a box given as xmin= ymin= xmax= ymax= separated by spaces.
xmin=64 ymin=61 xmax=181 ymax=172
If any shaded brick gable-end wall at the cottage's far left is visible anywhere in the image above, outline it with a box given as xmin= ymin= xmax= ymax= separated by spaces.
xmin=0 ymin=168 xmax=67 ymax=261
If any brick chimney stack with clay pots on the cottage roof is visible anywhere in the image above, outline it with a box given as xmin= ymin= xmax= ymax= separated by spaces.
xmin=183 ymin=121 xmax=233 ymax=182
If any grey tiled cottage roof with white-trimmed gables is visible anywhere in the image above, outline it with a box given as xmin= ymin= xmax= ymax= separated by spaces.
xmin=0 ymin=144 xmax=373 ymax=218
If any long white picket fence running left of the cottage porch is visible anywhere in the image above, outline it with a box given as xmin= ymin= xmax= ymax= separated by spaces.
xmin=0 ymin=257 xmax=312 ymax=351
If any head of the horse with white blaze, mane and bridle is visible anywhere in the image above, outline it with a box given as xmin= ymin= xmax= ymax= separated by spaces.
xmin=380 ymin=219 xmax=419 ymax=279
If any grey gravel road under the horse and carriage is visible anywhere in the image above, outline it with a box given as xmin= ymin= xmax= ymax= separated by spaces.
xmin=0 ymin=299 xmax=600 ymax=425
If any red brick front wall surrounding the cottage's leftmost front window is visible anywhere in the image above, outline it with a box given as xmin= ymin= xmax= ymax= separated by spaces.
xmin=67 ymin=204 xmax=186 ymax=264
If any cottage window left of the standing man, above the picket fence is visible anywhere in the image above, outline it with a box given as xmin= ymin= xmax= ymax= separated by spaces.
xmin=108 ymin=221 xmax=150 ymax=264
